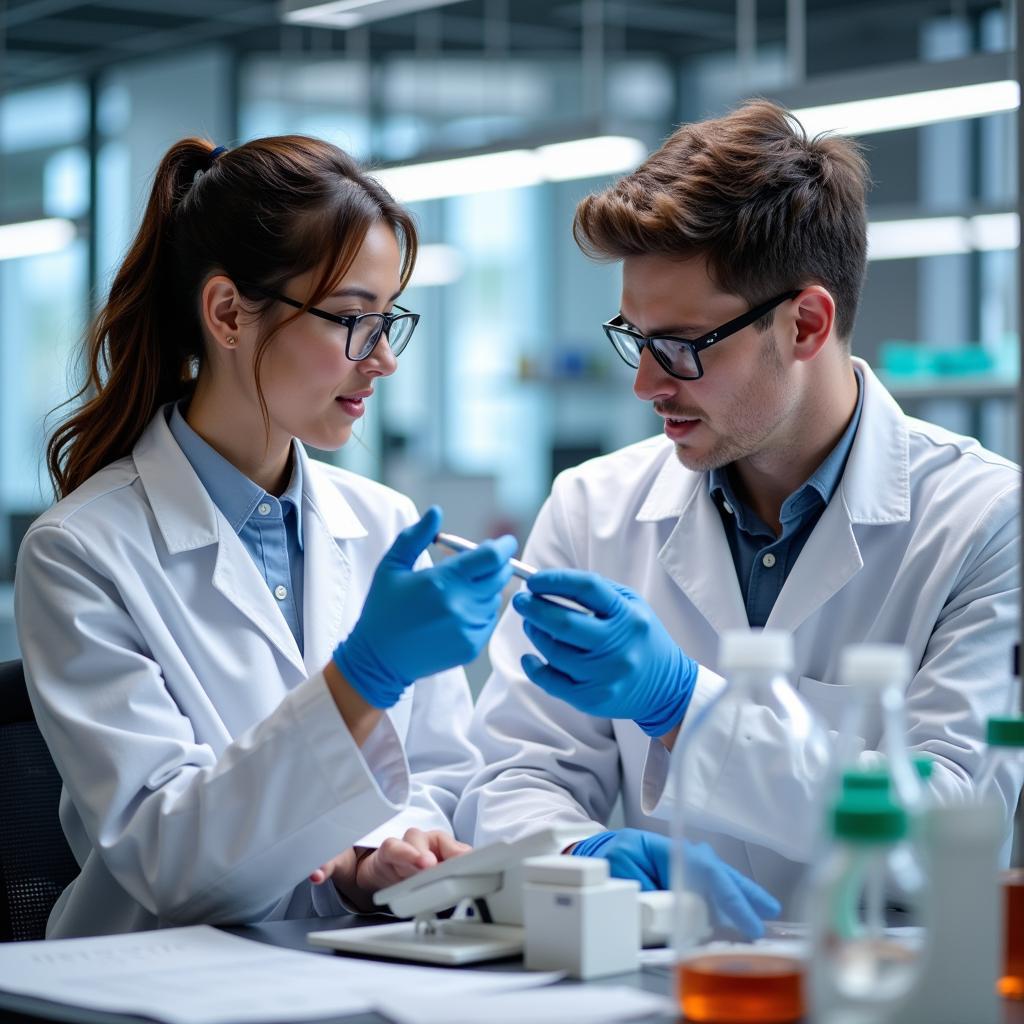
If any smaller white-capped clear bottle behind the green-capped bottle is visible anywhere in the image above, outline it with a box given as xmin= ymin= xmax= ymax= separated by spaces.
xmin=838 ymin=643 xmax=930 ymax=815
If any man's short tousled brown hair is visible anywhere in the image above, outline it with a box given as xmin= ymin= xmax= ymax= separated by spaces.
xmin=572 ymin=99 xmax=867 ymax=341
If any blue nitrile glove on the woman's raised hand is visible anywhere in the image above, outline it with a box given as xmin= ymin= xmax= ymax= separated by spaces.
xmin=334 ymin=506 xmax=517 ymax=708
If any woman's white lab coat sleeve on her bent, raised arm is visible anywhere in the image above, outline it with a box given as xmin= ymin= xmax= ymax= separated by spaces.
xmin=15 ymin=524 xmax=409 ymax=925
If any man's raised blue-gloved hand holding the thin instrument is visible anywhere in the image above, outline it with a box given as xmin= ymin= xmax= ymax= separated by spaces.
xmin=512 ymin=569 xmax=697 ymax=736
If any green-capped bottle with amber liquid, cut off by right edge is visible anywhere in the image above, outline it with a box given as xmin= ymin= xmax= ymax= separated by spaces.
xmin=977 ymin=647 xmax=1024 ymax=999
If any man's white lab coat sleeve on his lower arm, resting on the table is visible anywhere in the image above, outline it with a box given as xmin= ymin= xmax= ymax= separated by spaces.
xmin=456 ymin=485 xmax=620 ymax=845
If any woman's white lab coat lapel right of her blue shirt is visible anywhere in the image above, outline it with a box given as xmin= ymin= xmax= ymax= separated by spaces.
xmin=302 ymin=455 xmax=367 ymax=675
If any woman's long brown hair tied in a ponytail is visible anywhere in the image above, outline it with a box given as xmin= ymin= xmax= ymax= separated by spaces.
xmin=46 ymin=135 xmax=417 ymax=498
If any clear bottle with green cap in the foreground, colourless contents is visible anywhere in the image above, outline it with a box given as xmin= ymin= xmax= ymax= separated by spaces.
xmin=808 ymin=769 xmax=926 ymax=1024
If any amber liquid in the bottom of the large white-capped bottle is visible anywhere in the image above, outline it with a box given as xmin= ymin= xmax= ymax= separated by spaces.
xmin=676 ymin=953 xmax=804 ymax=1024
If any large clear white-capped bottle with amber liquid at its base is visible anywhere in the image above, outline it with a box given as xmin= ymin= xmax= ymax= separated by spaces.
xmin=672 ymin=630 xmax=834 ymax=1024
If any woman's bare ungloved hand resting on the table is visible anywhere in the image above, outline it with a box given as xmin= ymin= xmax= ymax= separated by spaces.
xmin=309 ymin=828 xmax=472 ymax=912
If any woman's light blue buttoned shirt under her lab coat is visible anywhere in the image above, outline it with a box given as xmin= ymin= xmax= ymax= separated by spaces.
xmin=169 ymin=402 xmax=304 ymax=653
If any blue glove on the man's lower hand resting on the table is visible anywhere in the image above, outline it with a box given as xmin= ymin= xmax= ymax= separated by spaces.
xmin=572 ymin=828 xmax=780 ymax=940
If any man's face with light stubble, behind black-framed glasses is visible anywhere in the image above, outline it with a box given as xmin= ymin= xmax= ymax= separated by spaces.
xmin=621 ymin=256 xmax=797 ymax=472
